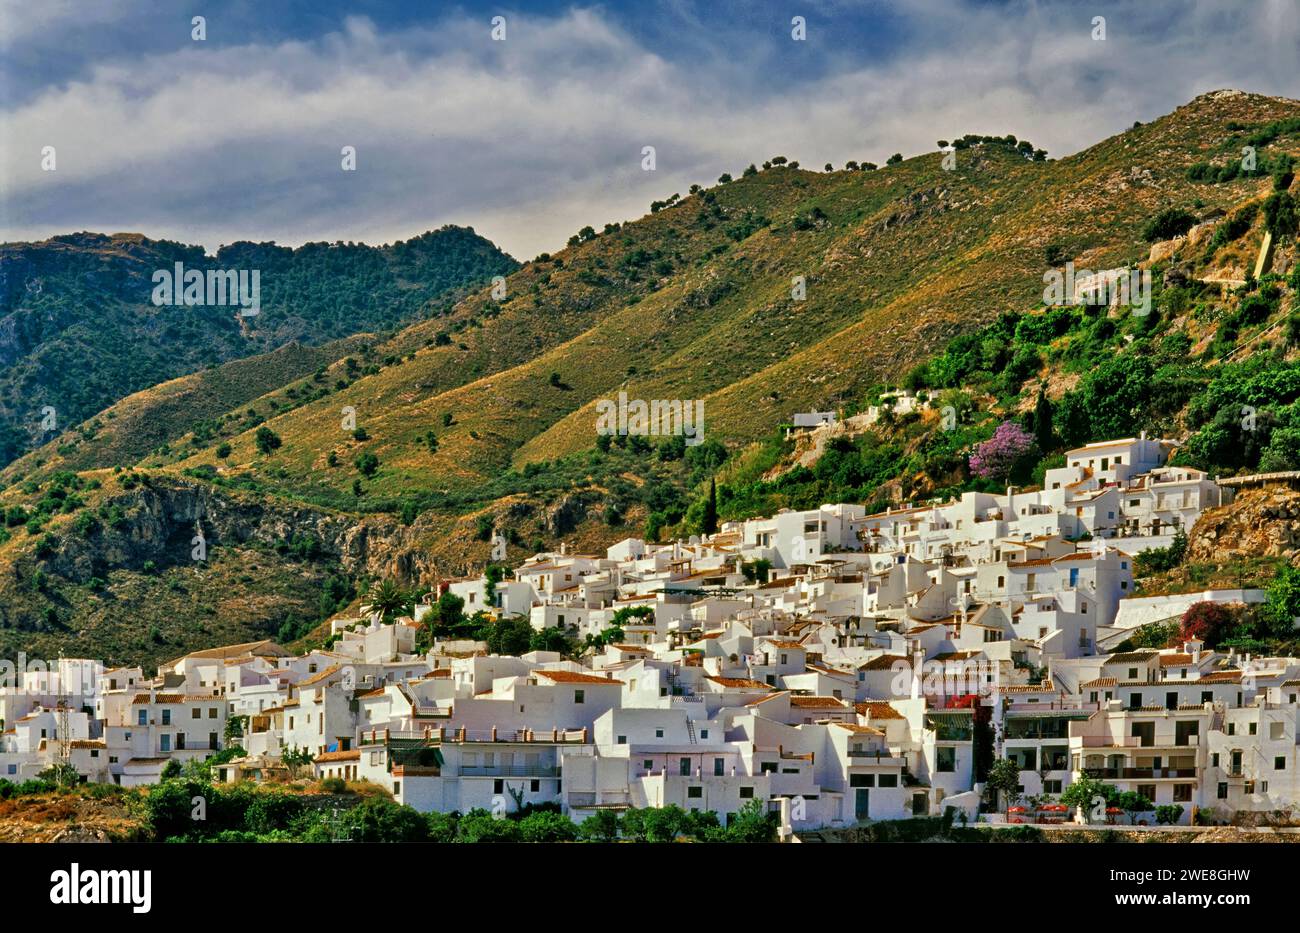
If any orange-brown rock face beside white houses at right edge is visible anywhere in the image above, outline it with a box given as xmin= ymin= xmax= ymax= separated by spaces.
xmin=1187 ymin=485 xmax=1300 ymax=565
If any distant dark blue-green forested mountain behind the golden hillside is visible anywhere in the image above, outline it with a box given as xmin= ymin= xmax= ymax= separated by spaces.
xmin=0 ymin=226 xmax=519 ymax=465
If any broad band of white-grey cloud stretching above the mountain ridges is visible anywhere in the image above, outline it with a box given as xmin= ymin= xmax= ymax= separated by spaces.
xmin=0 ymin=0 xmax=1300 ymax=259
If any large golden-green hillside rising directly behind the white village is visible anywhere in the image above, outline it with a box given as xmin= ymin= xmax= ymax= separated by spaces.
xmin=0 ymin=91 xmax=1300 ymax=660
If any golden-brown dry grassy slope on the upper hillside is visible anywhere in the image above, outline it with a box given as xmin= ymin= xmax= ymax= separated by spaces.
xmin=159 ymin=90 xmax=1300 ymax=500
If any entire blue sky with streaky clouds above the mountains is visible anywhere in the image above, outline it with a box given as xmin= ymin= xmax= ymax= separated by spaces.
xmin=0 ymin=0 xmax=1300 ymax=260
